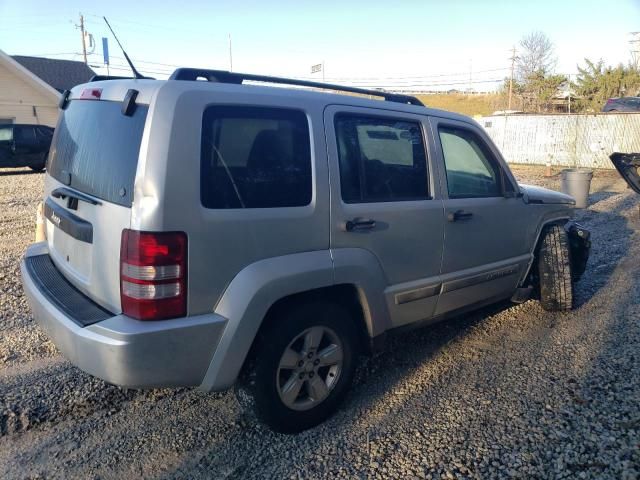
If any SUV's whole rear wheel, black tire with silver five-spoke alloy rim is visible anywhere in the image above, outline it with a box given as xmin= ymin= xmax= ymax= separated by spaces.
xmin=237 ymin=301 xmax=357 ymax=433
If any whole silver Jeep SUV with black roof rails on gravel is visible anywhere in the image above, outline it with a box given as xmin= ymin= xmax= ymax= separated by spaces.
xmin=21 ymin=69 xmax=589 ymax=432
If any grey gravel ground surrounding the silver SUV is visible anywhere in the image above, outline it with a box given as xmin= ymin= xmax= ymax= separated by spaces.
xmin=0 ymin=167 xmax=640 ymax=480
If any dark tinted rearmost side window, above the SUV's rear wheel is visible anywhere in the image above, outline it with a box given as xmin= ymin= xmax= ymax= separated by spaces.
xmin=200 ymin=106 xmax=311 ymax=208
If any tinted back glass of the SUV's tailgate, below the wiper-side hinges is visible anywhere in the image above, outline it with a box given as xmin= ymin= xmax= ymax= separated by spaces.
xmin=47 ymin=100 xmax=148 ymax=207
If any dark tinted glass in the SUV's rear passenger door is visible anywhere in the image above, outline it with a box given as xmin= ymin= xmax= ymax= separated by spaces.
xmin=335 ymin=114 xmax=428 ymax=203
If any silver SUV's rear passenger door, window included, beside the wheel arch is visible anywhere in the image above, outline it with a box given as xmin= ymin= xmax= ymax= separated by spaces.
xmin=324 ymin=105 xmax=444 ymax=327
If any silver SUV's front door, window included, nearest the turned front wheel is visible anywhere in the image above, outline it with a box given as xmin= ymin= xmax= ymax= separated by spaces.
xmin=431 ymin=117 xmax=536 ymax=315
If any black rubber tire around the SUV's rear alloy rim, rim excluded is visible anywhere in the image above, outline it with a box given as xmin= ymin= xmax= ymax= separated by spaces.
xmin=236 ymin=301 xmax=357 ymax=433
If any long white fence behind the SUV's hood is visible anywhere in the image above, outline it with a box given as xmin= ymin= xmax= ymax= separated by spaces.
xmin=478 ymin=113 xmax=640 ymax=168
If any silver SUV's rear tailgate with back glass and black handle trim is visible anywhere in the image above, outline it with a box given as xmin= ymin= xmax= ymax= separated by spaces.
xmin=44 ymin=100 xmax=148 ymax=313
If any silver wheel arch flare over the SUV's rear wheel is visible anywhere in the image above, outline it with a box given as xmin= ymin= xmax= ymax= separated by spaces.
xmin=200 ymin=249 xmax=390 ymax=391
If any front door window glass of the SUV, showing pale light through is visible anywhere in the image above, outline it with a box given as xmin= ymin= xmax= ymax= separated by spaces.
xmin=438 ymin=127 xmax=501 ymax=198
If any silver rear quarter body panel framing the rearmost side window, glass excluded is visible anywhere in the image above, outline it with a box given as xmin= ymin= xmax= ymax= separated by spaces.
xmin=137 ymin=86 xmax=329 ymax=315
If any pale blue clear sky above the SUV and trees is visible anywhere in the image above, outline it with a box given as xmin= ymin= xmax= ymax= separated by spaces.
xmin=0 ymin=0 xmax=640 ymax=91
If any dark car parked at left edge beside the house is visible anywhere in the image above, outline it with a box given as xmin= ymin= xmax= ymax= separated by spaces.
xmin=0 ymin=124 xmax=53 ymax=172
